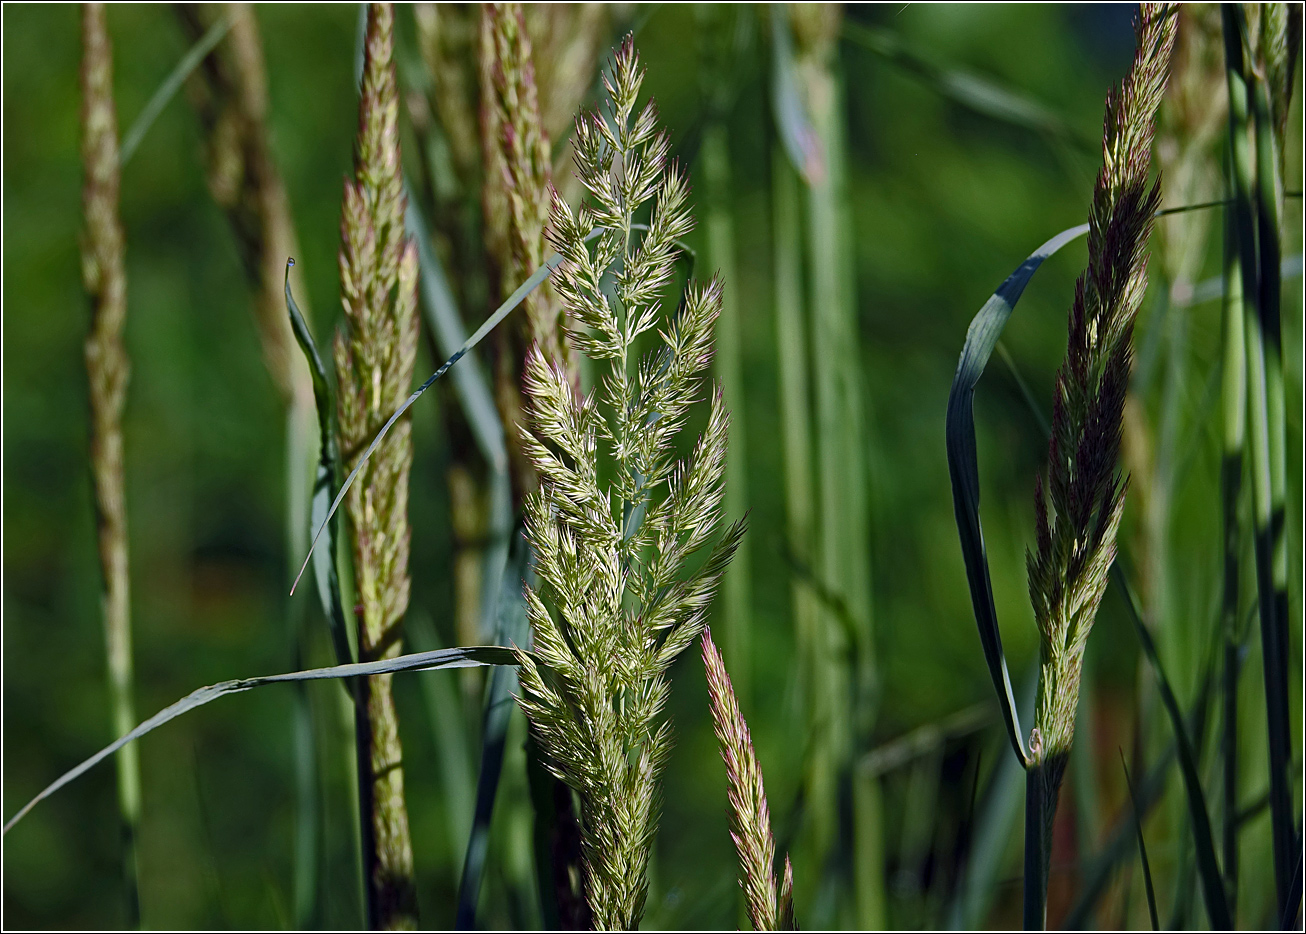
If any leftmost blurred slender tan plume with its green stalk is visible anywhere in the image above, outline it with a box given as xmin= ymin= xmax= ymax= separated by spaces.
xmin=81 ymin=3 xmax=141 ymax=926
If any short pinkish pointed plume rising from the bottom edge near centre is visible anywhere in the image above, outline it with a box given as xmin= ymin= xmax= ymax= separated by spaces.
xmin=703 ymin=628 xmax=794 ymax=931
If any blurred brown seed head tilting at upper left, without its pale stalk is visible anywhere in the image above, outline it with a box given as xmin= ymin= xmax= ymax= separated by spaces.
xmin=176 ymin=4 xmax=313 ymax=409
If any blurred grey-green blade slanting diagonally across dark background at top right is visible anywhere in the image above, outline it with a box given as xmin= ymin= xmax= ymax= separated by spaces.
xmin=842 ymin=20 xmax=1098 ymax=154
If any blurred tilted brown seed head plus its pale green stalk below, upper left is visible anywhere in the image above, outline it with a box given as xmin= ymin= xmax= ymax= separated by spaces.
xmin=176 ymin=4 xmax=331 ymax=927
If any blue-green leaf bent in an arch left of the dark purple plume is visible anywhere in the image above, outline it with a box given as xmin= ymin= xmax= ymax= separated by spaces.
xmin=947 ymin=223 xmax=1088 ymax=764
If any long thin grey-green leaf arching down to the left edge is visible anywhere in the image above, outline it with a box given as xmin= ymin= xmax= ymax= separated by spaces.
xmin=4 ymin=645 xmax=517 ymax=833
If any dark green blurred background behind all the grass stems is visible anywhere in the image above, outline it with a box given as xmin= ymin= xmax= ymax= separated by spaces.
xmin=3 ymin=4 xmax=1301 ymax=927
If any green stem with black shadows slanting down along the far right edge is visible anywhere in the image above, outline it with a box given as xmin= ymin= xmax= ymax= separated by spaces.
xmin=1222 ymin=4 xmax=1297 ymax=910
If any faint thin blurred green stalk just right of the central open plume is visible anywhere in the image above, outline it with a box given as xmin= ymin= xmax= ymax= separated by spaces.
xmin=700 ymin=119 xmax=752 ymax=703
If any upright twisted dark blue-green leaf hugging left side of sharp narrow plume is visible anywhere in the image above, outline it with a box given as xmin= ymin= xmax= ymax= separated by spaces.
xmin=286 ymin=257 xmax=354 ymax=665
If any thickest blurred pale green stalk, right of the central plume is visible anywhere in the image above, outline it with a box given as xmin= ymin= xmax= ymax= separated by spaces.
xmin=791 ymin=4 xmax=884 ymax=929
